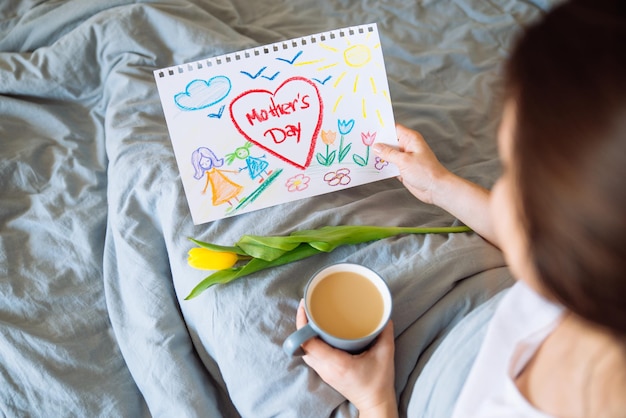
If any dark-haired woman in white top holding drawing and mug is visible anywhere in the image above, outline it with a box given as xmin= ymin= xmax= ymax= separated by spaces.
xmin=297 ymin=1 xmax=626 ymax=417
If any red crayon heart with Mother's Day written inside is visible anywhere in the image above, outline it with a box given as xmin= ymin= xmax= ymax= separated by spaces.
xmin=229 ymin=77 xmax=324 ymax=170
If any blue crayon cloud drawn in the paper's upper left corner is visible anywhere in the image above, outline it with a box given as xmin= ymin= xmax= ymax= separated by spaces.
xmin=174 ymin=75 xmax=232 ymax=110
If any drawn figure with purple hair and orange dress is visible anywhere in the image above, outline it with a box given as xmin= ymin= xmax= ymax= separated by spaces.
xmin=191 ymin=147 xmax=243 ymax=206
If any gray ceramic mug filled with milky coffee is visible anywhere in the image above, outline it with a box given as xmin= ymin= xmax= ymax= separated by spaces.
xmin=283 ymin=263 xmax=393 ymax=356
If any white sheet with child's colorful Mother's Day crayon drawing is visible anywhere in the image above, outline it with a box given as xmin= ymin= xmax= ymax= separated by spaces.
xmin=154 ymin=24 xmax=398 ymax=224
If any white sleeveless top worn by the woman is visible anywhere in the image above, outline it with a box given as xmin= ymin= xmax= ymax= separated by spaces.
xmin=453 ymin=282 xmax=563 ymax=418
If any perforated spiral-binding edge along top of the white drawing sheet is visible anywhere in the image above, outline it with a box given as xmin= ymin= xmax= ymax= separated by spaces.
xmin=155 ymin=23 xmax=376 ymax=78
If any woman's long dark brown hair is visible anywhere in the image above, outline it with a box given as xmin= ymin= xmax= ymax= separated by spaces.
xmin=506 ymin=0 xmax=626 ymax=339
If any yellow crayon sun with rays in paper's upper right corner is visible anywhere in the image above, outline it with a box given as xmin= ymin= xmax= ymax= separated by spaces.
xmin=294 ymin=32 xmax=391 ymax=126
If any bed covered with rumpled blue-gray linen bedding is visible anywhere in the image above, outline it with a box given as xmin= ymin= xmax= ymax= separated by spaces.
xmin=0 ymin=0 xmax=551 ymax=417
